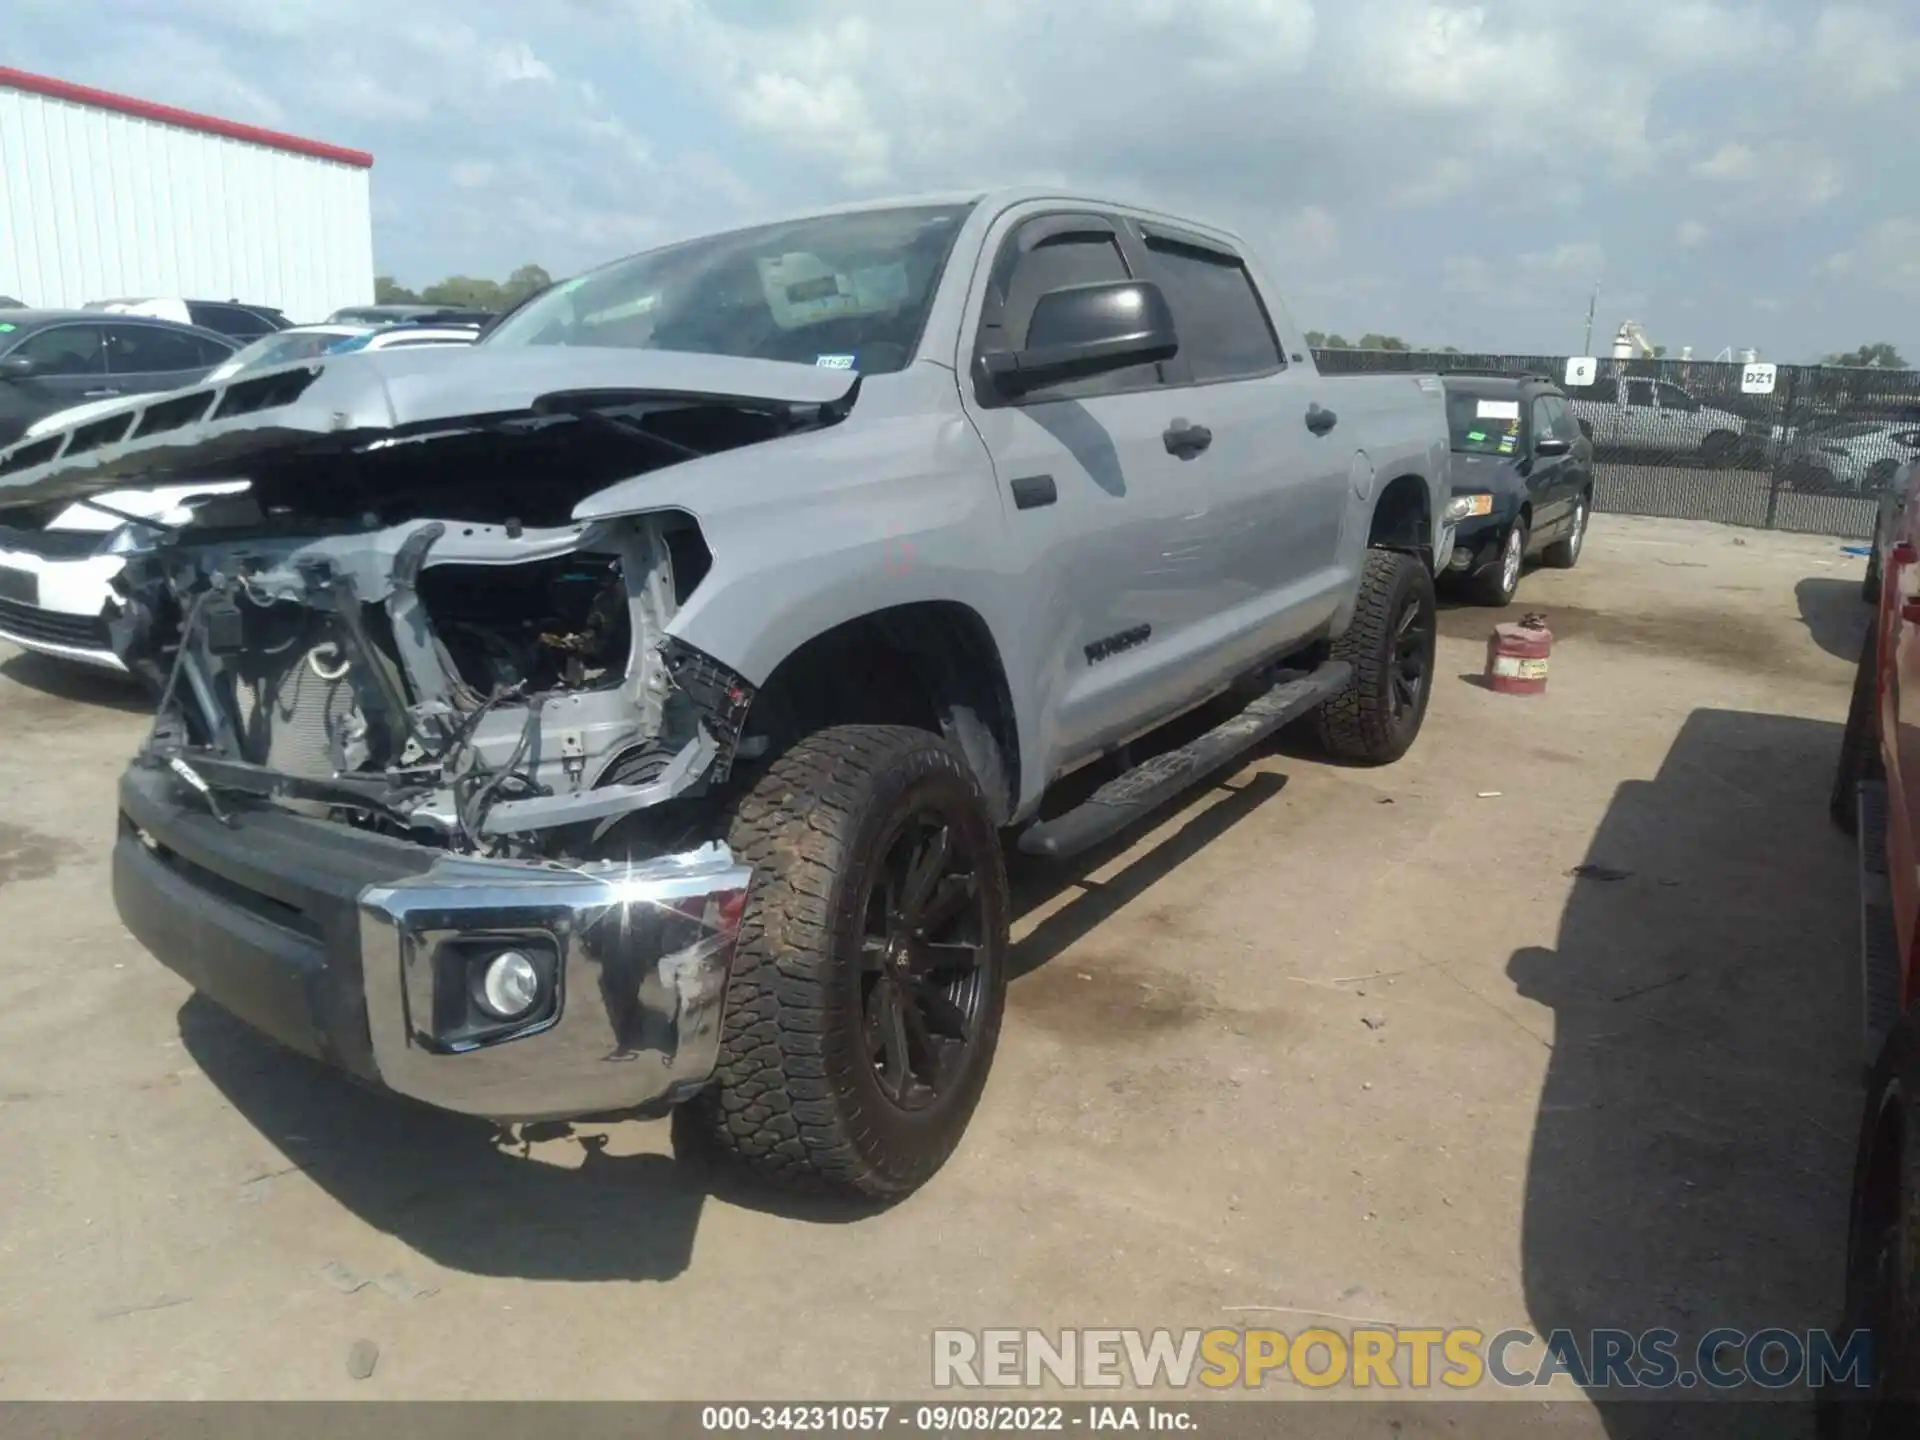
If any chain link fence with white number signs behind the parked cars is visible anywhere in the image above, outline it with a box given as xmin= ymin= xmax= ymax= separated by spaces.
xmin=1313 ymin=349 xmax=1920 ymax=540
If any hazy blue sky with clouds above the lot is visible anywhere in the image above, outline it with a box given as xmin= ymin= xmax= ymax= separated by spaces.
xmin=6 ymin=0 xmax=1920 ymax=361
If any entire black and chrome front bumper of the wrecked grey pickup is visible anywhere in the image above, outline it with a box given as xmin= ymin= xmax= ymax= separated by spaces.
xmin=113 ymin=766 xmax=751 ymax=1121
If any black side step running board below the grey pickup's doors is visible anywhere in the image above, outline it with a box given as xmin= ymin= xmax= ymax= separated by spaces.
xmin=1020 ymin=660 xmax=1354 ymax=860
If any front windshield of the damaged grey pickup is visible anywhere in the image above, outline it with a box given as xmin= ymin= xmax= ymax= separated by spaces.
xmin=480 ymin=205 xmax=972 ymax=374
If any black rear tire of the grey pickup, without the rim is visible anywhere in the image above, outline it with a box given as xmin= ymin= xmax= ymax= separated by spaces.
xmin=1308 ymin=549 xmax=1436 ymax=766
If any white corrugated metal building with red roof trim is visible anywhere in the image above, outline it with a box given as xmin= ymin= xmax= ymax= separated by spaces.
xmin=0 ymin=67 xmax=372 ymax=323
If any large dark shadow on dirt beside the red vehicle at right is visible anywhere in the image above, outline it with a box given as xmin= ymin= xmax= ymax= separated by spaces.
xmin=1507 ymin=710 xmax=1860 ymax=1436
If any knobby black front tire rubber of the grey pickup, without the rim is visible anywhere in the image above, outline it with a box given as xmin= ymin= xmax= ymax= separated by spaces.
xmin=676 ymin=726 xmax=1010 ymax=1200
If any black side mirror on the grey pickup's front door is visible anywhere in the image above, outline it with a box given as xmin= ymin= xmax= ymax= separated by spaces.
xmin=987 ymin=280 xmax=1181 ymax=396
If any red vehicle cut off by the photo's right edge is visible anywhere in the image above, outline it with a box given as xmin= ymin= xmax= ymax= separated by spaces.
xmin=1820 ymin=463 xmax=1920 ymax=1436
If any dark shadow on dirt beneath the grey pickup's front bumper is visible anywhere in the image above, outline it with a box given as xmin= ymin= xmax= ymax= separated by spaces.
xmin=179 ymin=995 xmax=874 ymax=1281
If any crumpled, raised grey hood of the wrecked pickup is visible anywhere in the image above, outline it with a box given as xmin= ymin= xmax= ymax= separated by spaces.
xmin=0 ymin=346 xmax=860 ymax=511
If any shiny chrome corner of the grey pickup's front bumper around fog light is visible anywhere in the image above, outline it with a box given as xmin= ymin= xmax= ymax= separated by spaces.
xmin=361 ymin=845 xmax=751 ymax=1121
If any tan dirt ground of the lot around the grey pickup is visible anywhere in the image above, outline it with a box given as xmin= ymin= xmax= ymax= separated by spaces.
xmin=0 ymin=516 xmax=1866 ymax=1432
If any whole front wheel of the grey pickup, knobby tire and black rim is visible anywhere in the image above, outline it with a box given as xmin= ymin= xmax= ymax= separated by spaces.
xmin=685 ymin=726 xmax=1012 ymax=1200
